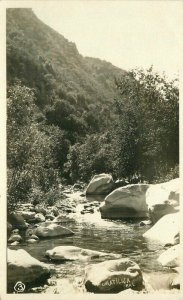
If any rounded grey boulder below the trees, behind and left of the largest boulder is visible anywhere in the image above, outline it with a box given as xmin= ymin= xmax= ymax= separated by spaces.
xmin=86 ymin=173 xmax=114 ymax=195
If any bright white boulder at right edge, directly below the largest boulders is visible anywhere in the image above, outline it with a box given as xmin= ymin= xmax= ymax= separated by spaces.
xmin=143 ymin=213 xmax=180 ymax=245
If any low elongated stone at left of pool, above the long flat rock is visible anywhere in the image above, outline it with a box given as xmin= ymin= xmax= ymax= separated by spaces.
xmin=35 ymin=223 xmax=74 ymax=238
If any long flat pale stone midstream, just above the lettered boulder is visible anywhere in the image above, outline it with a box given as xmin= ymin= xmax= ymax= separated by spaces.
xmin=46 ymin=246 xmax=120 ymax=261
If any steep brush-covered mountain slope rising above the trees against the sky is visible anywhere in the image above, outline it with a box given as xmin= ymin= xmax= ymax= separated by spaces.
xmin=7 ymin=8 xmax=126 ymax=106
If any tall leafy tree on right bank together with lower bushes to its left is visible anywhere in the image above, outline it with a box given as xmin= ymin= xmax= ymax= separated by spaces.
xmin=67 ymin=68 xmax=179 ymax=182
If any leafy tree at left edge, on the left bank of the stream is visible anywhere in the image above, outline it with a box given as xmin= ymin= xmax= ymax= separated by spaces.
xmin=7 ymin=84 xmax=58 ymax=205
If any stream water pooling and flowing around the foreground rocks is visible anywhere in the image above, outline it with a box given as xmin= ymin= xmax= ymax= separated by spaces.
xmin=12 ymin=199 xmax=177 ymax=294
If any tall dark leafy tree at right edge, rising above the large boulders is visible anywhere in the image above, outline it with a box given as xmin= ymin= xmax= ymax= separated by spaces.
xmin=111 ymin=68 xmax=179 ymax=180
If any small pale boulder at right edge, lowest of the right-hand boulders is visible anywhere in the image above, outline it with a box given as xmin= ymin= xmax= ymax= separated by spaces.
xmin=158 ymin=244 xmax=181 ymax=268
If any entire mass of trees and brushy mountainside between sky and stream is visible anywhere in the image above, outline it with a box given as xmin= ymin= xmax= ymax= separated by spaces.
xmin=7 ymin=8 xmax=179 ymax=206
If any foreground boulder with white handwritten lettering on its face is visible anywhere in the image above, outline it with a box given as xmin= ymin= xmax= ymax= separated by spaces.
xmin=84 ymin=258 xmax=143 ymax=293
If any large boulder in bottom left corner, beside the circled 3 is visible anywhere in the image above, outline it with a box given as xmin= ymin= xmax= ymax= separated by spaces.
xmin=7 ymin=249 xmax=50 ymax=292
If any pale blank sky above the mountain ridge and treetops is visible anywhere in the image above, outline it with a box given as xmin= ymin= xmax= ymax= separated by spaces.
xmin=33 ymin=0 xmax=183 ymax=77
